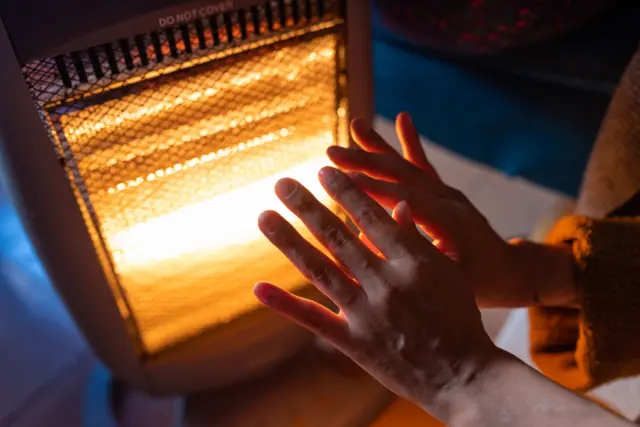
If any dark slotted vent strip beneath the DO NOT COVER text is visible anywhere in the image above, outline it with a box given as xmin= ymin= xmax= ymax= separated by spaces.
xmin=23 ymin=0 xmax=343 ymax=106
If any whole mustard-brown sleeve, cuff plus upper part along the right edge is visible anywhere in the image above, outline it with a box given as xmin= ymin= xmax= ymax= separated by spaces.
xmin=529 ymin=40 xmax=640 ymax=391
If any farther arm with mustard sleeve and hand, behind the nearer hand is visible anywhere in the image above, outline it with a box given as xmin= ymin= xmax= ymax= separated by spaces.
xmin=329 ymin=46 xmax=640 ymax=391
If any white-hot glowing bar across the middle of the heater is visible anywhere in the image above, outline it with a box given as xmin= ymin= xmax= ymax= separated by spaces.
xmin=109 ymin=141 xmax=332 ymax=268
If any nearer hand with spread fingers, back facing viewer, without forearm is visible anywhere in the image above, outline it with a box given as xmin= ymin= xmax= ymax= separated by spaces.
xmin=254 ymin=168 xmax=500 ymax=421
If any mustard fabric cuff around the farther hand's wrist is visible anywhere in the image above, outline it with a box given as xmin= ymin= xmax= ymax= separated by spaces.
xmin=529 ymin=217 xmax=640 ymax=391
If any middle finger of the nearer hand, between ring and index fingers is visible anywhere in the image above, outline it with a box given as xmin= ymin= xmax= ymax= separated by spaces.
xmin=276 ymin=178 xmax=380 ymax=281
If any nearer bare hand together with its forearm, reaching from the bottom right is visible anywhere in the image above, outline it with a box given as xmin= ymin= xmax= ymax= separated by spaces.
xmin=254 ymin=121 xmax=627 ymax=427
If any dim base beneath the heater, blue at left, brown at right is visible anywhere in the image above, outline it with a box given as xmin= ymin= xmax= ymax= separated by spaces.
xmin=83 ymin=349 xmax=393 ymax=427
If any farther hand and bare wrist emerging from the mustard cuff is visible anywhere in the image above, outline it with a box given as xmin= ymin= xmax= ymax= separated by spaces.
xmin=327 ymin=114 xmax=576 ymax=307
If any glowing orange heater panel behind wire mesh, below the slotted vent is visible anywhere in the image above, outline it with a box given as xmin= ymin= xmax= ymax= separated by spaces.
xmin=59 ymin=35 xmax=345 ymax=353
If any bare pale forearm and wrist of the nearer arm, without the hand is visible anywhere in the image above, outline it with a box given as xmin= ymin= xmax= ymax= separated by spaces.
xmin=436 ymin=355 xmax=632 ymax=427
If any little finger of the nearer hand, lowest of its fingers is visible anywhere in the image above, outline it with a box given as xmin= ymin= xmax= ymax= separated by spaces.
xmin=253 ymin=282 xmax=349 ymax=347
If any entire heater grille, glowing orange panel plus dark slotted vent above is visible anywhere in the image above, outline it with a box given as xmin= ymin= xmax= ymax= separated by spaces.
xmin=23 ymin=1 xmax=347 ymax=355
